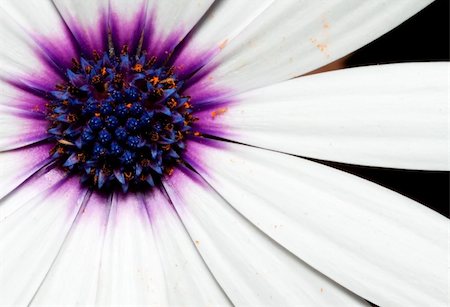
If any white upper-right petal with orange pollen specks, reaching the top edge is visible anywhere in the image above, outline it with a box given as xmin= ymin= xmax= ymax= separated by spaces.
xmin=188 ymin=0 xmax=431 ymax=97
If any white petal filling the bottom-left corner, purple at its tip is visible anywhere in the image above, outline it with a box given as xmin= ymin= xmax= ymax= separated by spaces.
xmin=0 ymin=176 xmax=83 ymax=306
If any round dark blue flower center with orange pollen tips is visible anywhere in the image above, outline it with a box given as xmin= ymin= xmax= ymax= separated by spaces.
xmin=47 ymin=46 xmax=195 ymax=191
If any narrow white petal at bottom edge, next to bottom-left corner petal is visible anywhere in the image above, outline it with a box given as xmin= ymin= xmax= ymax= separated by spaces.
xmin=31 ymin=192 xmax=111 ymax=306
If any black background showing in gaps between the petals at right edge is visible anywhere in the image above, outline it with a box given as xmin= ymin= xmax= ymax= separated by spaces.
xmin=321 ymin=0 xmax=450 ymax=220
